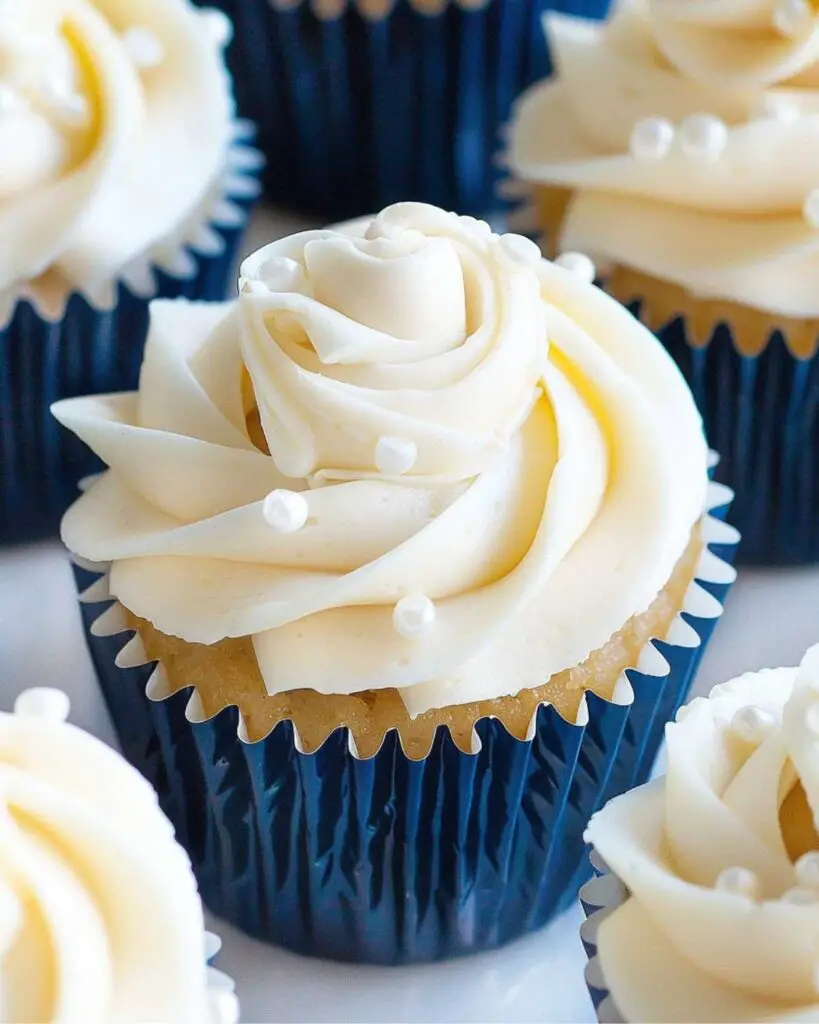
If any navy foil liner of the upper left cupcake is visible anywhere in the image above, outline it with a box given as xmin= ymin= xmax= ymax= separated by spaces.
xmin=0 ymin=122 xmax=262 ymax=544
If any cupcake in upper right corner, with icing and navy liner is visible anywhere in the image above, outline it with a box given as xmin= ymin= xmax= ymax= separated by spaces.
xmin=509 ymin=0 xmax=819 ymax=563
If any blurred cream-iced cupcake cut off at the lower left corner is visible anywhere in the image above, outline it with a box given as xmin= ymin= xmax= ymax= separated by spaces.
xmin=0 ymin=689 xmax=238 ymax=1024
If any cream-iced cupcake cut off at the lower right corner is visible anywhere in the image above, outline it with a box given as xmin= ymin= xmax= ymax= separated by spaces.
xmin=583 ymin=647 xmax=819 ymax=1024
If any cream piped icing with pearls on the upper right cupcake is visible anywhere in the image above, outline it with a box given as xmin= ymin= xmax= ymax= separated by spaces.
xmin=510 ymin=0 xmax=819 ymax=317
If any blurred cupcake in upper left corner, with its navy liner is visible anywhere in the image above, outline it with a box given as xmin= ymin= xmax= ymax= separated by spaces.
xmin=0 ymin=0 xmax=259 ymax=543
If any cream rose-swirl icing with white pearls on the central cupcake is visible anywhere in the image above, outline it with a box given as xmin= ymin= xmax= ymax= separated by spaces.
xmin=54 ymin=204 xmax=706 ymax=714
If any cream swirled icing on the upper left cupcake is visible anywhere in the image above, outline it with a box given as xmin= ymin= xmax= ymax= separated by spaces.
xmin=0 ymin=0 xmax=232 ymax=309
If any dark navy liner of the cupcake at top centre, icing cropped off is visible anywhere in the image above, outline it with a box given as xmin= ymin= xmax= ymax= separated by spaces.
xmin=198 ymin=0 xmax=609 ymax=220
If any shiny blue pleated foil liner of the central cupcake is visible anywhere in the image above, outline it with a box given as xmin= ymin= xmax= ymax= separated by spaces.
xmin=76 ymin=484 xmax=738 ymax=964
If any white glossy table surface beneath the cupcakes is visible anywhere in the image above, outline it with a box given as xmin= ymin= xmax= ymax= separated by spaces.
xmin=0 ymin=209 xmax=819 ymax=1024
